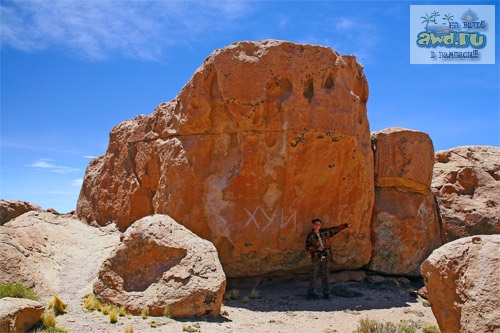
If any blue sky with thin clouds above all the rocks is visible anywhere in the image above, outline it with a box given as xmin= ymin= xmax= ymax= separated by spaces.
xmin=0 ymin=0 xmax=500 ymax=213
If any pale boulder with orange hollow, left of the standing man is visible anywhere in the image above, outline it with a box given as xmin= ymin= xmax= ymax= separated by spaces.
xmin=94 ymin=215 xmax=226 ymax=317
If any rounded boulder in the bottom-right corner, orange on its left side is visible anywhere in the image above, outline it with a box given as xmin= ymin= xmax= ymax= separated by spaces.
xmin=421 ymin=235 xmax=500 ymax=333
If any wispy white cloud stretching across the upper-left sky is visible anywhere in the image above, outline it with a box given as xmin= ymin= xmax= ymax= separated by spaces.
xmin=0 ymin=0 xmax=247 ymax=60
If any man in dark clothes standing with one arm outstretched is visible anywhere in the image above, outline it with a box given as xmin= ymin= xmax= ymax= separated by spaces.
xmin=306 ymin=219 xmax=348 ymax=299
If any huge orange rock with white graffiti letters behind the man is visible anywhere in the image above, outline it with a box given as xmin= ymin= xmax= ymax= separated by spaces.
xmin=77 ymin=41 xmax=374 ymax=277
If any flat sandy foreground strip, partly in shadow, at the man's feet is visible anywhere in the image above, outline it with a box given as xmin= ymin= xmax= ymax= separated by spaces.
xmin=49 ymin=278 xmax=437 ymax=333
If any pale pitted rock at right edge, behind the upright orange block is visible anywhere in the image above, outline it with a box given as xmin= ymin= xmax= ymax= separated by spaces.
xmin=432 ymin=146 xmax=500 ymax=242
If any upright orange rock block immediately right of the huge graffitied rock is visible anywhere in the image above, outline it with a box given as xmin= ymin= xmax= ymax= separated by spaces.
xmin=368 ymin=127 xmax=442 ymax=275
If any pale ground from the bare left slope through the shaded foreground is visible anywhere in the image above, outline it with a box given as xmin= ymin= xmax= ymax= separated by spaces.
xmin=0 ymin=212 xmax=437 ymax=333
